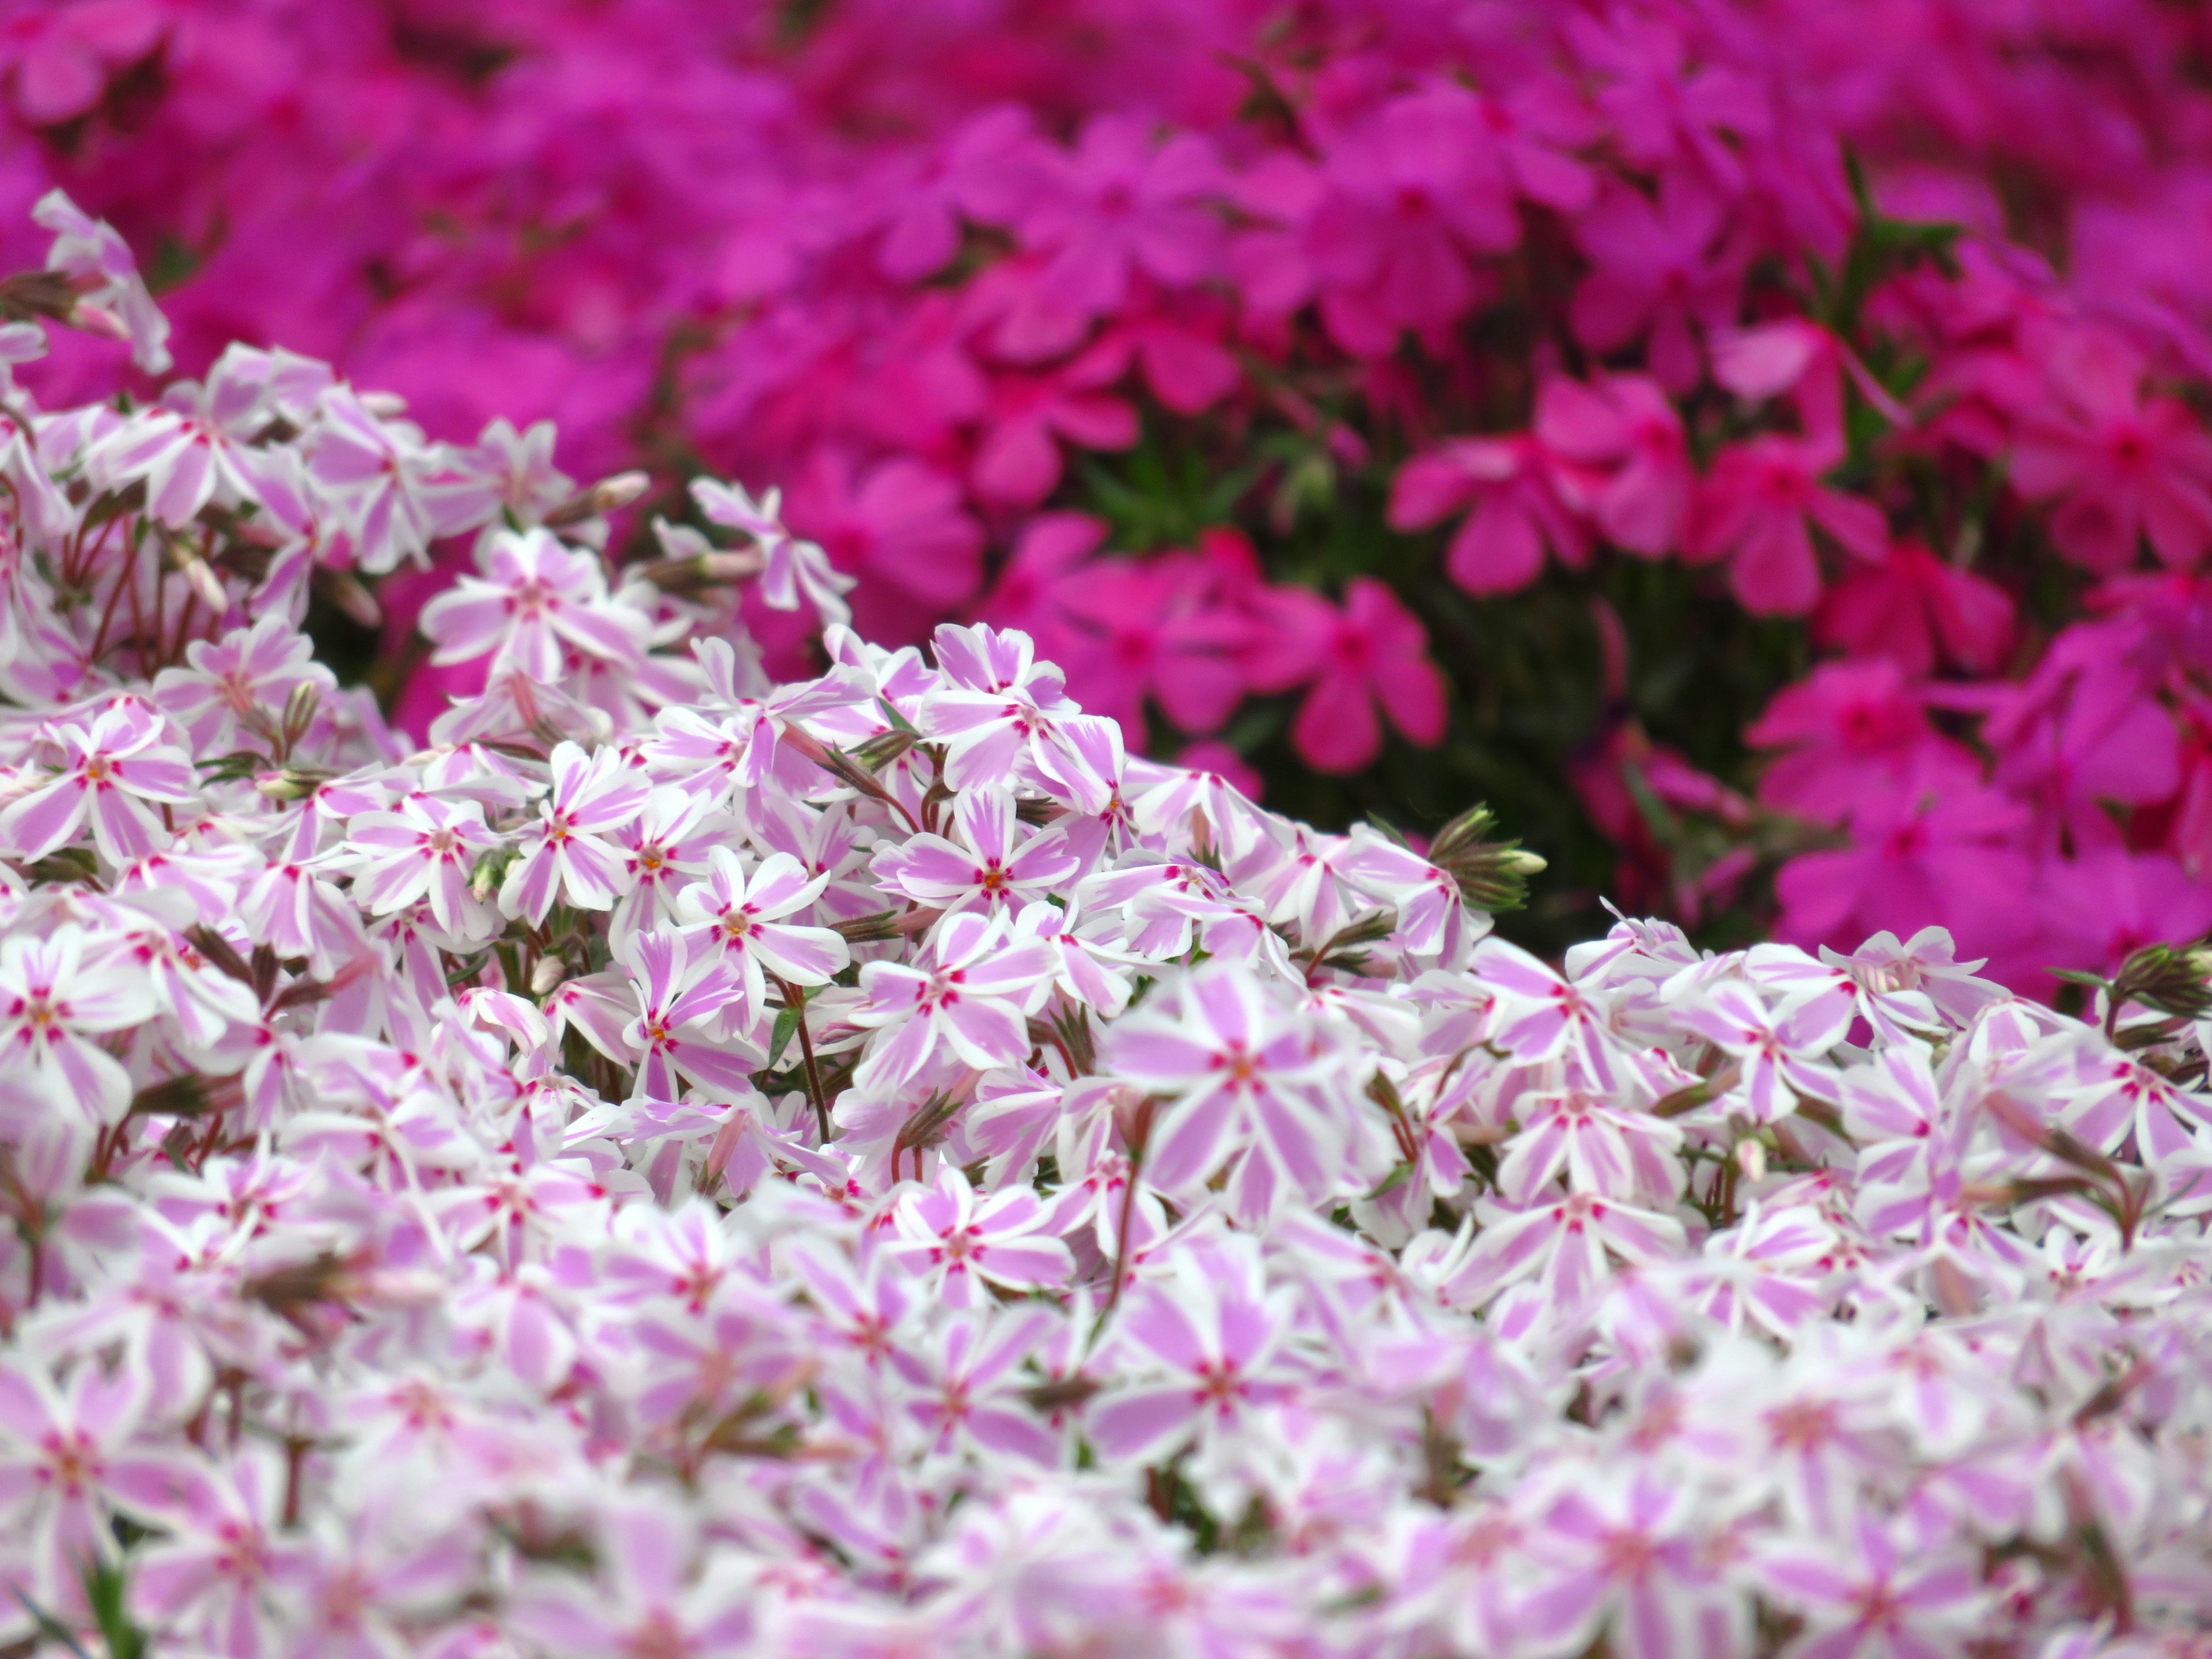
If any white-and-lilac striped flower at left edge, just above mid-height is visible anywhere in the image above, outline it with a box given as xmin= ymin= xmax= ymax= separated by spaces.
xmin=0 ymin=697 xmax=197 ymax=865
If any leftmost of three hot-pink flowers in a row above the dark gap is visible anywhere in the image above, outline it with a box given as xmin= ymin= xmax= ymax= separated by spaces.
xmin=1389 ymin=435 xmax=1590 ymax=595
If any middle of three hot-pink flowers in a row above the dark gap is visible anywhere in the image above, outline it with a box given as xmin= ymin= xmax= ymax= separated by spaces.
xmin=1539 ymin=374 xmax=1692 ymax=555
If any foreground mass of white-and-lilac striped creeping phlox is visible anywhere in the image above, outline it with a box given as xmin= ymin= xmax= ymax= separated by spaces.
xmin=0 ymin=201 xmax=2212 ymax=1659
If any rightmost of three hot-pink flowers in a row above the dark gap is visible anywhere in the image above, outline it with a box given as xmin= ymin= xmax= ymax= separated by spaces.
xmin=1683 ymin=434 xmax=1889 ymax=617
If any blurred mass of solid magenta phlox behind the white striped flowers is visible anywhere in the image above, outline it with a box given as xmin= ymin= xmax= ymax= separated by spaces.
xmin=13 ymin=0 xmax=2212 ymax=993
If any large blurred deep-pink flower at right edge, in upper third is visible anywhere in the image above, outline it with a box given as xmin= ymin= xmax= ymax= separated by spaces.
xmin=2013 ymin=336 xmax=2212 ymax=573
